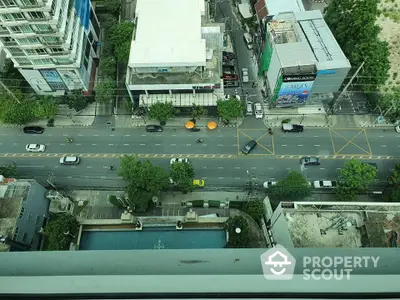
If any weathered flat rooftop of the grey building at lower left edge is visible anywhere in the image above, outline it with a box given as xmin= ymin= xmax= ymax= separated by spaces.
xmin=0 ymin=179 xmax=31 ymax=251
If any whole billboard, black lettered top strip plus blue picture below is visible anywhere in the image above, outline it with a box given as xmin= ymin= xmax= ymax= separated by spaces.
xmin=275 ymin=74 xmax=315 ymax=107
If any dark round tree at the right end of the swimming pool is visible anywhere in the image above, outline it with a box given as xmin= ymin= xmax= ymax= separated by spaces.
xmin=225 ymin=216 xmax=250 ymax=248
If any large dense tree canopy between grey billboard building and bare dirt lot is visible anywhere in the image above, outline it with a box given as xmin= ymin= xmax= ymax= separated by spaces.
xmin=324 ymin=0 xmax=389 ymax=92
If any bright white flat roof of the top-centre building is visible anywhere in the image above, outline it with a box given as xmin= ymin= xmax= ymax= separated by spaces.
xmin=129 ymin=0 xmax=206 ymax=68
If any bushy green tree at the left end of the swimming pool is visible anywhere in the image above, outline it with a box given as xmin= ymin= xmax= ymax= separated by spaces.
xmin=44 ymin=214 xmax=79 ymax=251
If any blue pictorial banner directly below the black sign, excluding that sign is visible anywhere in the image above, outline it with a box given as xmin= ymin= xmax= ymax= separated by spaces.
xmin=276 ymin=80 xmax=314 ymax=107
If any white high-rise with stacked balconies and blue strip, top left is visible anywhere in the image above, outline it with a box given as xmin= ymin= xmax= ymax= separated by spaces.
xmin=0 ymin=0 xmax=100 ymax=96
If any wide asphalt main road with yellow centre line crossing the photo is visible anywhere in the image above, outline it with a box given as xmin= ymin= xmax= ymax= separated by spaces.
xmin=0 ymin=128 xmax=400 ymax=187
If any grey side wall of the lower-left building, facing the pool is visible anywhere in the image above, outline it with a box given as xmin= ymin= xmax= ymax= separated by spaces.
xmin=16 ymin=182 xmax=50 ymax=250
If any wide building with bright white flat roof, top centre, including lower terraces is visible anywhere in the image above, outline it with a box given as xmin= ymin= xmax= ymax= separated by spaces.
xmin=126 ymin=0 xmax=224 ymax=107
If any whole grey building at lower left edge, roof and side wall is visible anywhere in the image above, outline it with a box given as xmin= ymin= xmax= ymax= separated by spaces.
xmin=0 ymin=176 xmax=50 ymax=252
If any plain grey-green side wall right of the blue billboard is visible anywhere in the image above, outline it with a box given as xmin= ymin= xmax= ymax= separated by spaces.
xmin=311 ymin=67 xmax=350 ymax=94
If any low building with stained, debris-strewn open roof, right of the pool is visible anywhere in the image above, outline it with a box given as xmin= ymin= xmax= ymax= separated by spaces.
xmin=268 ymin=202 xmax=400 ymax=248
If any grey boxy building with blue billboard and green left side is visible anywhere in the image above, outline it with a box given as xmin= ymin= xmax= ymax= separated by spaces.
xmin=259 ymin=10 xmax=351 ymax=113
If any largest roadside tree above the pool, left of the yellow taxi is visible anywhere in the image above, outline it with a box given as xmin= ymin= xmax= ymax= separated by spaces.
xmin=119 ymin=155 xmax=169 ymax=212
